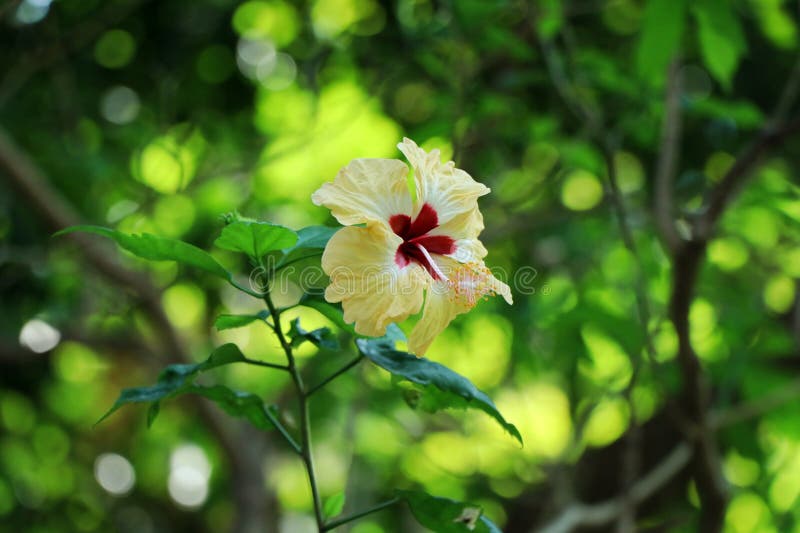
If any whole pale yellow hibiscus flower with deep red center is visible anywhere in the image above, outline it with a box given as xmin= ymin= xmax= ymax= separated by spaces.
xmin=311 ymin=139 xmax=512 ymax=355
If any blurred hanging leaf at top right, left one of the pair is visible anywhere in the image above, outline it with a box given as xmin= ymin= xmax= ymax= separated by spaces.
xmin=636 ymin=0 xmax=686 ymax=85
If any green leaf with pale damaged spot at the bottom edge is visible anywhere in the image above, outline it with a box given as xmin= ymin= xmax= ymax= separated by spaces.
xmin=396 ymin=490 xmax=502 ymax=533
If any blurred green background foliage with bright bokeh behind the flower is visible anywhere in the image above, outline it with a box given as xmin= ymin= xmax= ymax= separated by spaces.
xmin=0 ymin=0 xmax=800 ymax=533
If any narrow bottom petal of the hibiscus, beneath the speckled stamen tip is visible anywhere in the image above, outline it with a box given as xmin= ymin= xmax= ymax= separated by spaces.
xmin=408 ymin=257 xmax=513 ymax=356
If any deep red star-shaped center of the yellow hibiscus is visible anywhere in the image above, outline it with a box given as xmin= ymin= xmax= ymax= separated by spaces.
xmin=389 ymin=203 xmax=456 ymax=279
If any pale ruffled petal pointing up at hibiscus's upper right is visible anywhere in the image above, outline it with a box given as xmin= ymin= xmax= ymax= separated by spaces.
xmin=397 ymin=138 xmax=489 ymax=229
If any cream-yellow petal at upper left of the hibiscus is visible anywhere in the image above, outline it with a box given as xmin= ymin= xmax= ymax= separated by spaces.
xmin=311 ymin=159 xmax=412 ymax=227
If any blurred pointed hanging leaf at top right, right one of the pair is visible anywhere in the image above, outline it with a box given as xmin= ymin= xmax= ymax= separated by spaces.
xmin=691 ymin=0 xmax=747 ymax=90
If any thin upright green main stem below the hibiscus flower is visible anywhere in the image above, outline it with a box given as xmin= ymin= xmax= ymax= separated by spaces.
xmin=264 ymin=291 xmax=325 ymax=531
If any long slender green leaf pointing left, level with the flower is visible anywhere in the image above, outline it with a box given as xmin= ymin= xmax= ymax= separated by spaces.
xmin=56 ymin=226 xmax=232 ymax=281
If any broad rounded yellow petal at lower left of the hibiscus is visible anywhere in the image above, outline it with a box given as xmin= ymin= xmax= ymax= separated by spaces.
xmin=322 ymin=223 xmax=430 ymax=336
